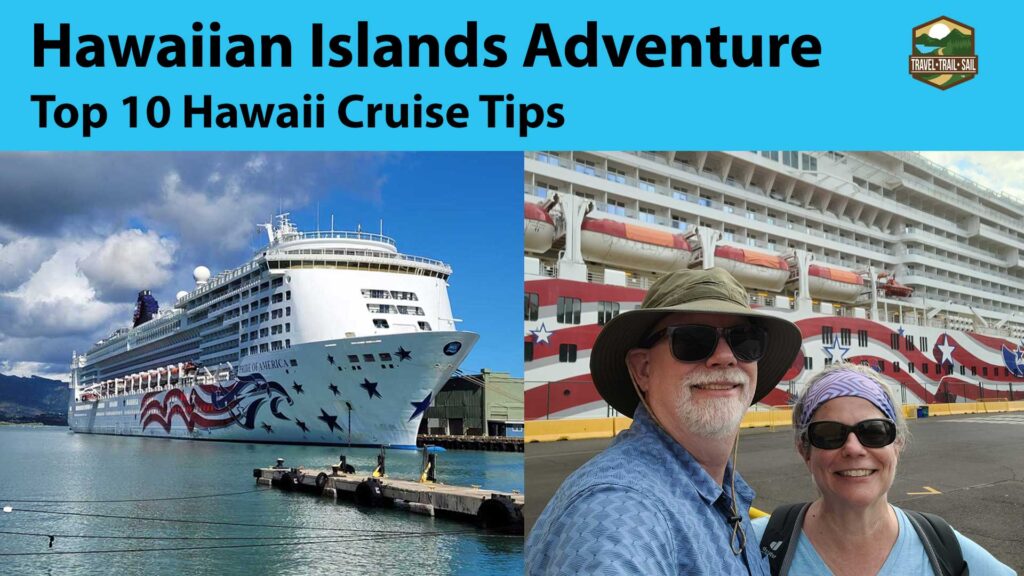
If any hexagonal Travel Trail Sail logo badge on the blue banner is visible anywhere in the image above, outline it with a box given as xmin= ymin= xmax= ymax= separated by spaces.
xmin=910 ymin=16 xmax=978 ymax=90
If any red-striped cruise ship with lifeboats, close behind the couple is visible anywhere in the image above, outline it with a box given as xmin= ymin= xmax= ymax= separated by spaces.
xmin=523 ymin=151 xmax=1024 ymax=420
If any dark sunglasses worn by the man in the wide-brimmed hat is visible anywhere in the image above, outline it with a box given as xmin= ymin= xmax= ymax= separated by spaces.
xmin=641 ymin=324 xmax=768 ymax=362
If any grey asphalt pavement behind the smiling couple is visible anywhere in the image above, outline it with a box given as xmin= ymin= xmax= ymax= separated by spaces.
xmin=523 ymin=412 xmax=1024 ymax=573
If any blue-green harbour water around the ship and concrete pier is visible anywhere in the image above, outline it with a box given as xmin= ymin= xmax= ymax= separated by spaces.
xmin=0 ymin=426 xmax=523 ymax=576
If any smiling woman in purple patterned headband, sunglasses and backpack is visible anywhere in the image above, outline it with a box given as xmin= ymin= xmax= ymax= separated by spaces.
xmin=753 ymin=364 xmax=1016 ymax=576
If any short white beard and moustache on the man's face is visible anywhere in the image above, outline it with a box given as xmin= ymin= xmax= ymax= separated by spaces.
xmin=676 ymin=368 xmax=752 ymax=439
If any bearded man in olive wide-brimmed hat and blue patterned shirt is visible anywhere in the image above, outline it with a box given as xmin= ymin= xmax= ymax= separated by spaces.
xmin=526 ymin=269 xmax=802 ymax=576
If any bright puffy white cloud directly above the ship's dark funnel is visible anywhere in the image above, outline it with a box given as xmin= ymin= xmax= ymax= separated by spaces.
xmin=78 ymin=230 xmax=177 ymax=301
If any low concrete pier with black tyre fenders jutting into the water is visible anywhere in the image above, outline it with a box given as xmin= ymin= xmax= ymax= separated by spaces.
xmin=253 ymin=460 xmax=525 ymax=534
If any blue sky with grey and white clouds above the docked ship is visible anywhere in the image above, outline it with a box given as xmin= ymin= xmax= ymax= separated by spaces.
xmin=0 ymin=152 xmax=522 ymax=378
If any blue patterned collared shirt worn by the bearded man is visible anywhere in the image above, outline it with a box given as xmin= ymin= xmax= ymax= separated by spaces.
xmin=526 ymin=405 xmax=768 ymax=576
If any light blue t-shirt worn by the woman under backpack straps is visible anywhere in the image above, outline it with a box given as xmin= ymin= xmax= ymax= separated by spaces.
xmin=751 ymin=506 xmax=1017 ymax=576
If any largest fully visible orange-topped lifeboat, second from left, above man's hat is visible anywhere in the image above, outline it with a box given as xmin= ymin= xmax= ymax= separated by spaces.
xmin=580 ymin=218 xmax=690 ymax=272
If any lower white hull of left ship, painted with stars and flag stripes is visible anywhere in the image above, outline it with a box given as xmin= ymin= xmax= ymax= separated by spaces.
xmin=69 ymin=332 xmax=477 ymax=448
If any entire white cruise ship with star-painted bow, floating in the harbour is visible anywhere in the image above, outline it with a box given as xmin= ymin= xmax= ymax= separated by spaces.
xmin=68 ymin=214 xmax=478 ymax=448
